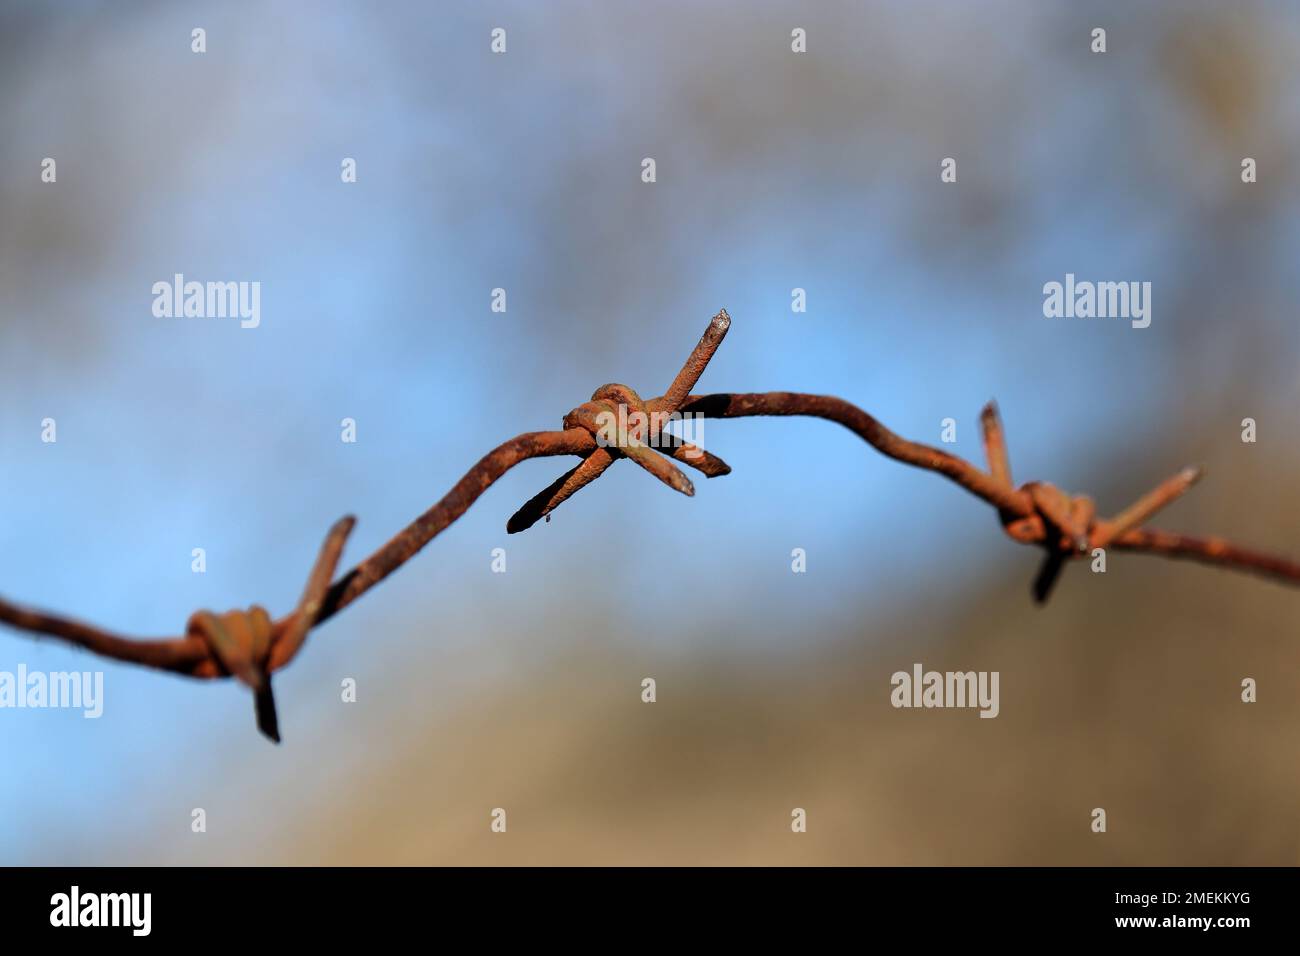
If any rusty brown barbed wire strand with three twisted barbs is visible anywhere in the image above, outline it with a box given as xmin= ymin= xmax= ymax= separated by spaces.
xmin=0 ymin=310 xmax=1300 ymax=743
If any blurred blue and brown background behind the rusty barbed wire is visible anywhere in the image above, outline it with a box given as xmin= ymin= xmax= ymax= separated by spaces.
xmin=0 ymin=0 xmax=1300 ymax=864
